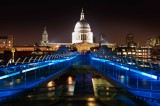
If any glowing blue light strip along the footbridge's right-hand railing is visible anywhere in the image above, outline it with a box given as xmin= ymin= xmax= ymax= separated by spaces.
xmin=91 ymin=57 xmax=158 ymax=79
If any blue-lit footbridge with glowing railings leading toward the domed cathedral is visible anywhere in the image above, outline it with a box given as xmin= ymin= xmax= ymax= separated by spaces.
xmin=0 ymin=46 xmax=160 ymax=105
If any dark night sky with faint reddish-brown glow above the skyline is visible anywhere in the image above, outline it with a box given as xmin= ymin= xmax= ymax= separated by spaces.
xmin=0 ymin=0 xmax=160 ymax=45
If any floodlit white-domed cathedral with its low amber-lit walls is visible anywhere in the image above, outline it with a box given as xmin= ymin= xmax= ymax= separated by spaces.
xmin=47 ymin=9 xmax=113 ymax=53
